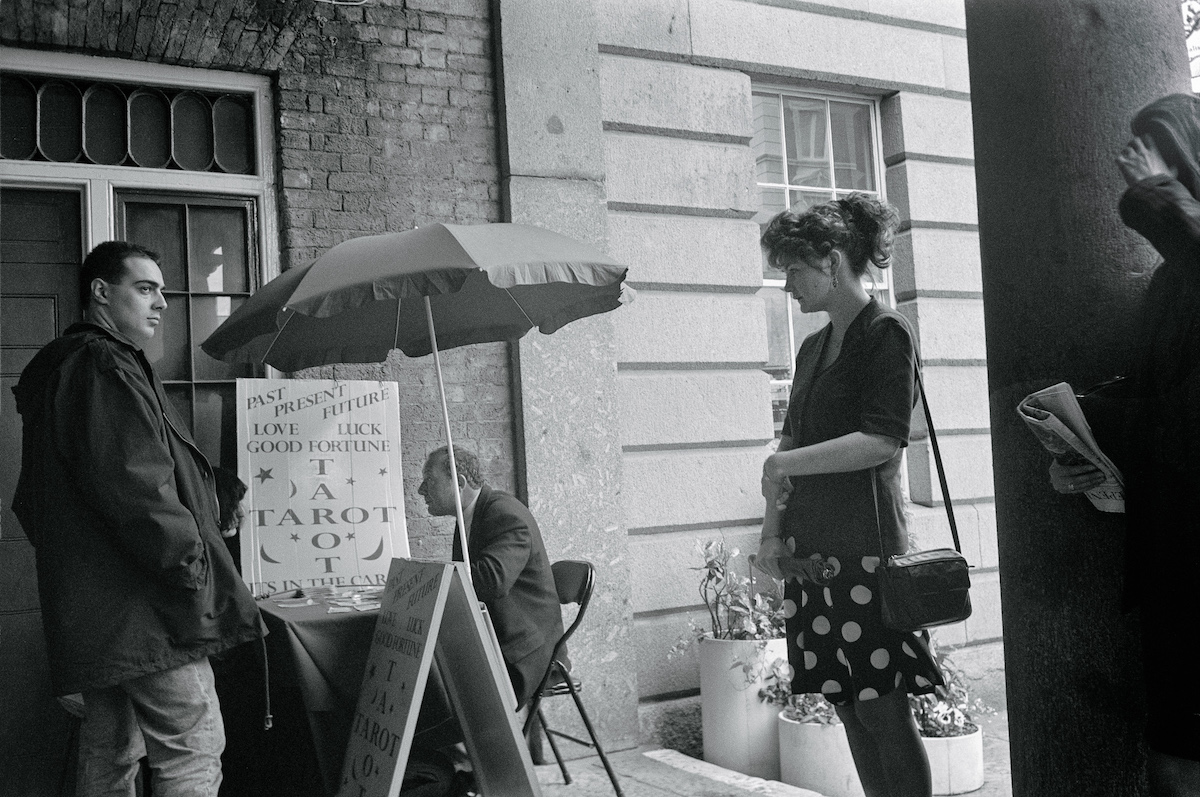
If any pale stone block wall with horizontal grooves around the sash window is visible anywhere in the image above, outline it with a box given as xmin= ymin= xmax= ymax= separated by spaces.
xmin=596 ymin=0 xmax=1001 ymax=741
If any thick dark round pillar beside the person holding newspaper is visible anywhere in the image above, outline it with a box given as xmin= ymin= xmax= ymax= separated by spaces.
xmin=966 ymin=0 xmax=1189 ymax=797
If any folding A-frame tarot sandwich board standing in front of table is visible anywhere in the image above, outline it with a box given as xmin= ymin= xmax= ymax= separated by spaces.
xmin=337 ymin=559 xmax=541 ymax=797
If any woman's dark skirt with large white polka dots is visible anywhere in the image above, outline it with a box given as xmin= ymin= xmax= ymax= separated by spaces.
xmin=784 ymin=556 xmax=942 ymax=706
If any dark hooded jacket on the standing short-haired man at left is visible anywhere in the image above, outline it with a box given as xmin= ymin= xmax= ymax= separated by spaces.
xmin=13 ymin=323 xmax=264 ymax=695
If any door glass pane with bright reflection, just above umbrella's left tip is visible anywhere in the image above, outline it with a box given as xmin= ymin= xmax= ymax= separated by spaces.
xmin=187 ymin=208 xmax=250 ymax=293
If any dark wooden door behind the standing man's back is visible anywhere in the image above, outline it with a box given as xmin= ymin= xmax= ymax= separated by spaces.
xmin=0 ymin=188 xmax=84 ymax=797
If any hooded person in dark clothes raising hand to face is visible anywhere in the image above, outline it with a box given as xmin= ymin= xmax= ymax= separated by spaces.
xmin=1050 ymin=94 xmax=1200 ymax=797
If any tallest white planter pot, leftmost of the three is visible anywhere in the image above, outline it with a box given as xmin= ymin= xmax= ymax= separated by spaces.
xmin=700 ymin=637 xmax=787 ymax=780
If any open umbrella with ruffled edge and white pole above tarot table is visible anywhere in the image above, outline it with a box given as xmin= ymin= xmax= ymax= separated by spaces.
xmin=200 ymin=223 xmax=634 ymax=583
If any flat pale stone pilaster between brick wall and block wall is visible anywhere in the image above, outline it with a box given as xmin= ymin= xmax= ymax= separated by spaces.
xmin=492 ymin=0 xmax=637 ymax=755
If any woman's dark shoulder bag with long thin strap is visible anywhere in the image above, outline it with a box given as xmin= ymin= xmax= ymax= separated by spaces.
xmin=871 ymin=368 xmax=971 ymax=631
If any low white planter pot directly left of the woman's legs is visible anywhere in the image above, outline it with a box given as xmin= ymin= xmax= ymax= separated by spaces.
xmin=778 ymin=712 xmax=863 ymax=797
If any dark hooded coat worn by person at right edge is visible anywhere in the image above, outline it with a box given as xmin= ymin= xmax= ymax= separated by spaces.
xmin=1120 ymin=95 xmax=1200 ymax=614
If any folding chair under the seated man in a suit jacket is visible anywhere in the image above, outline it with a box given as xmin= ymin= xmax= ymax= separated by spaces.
xmin=524 ymin=559 xmax=625 ymax=797
